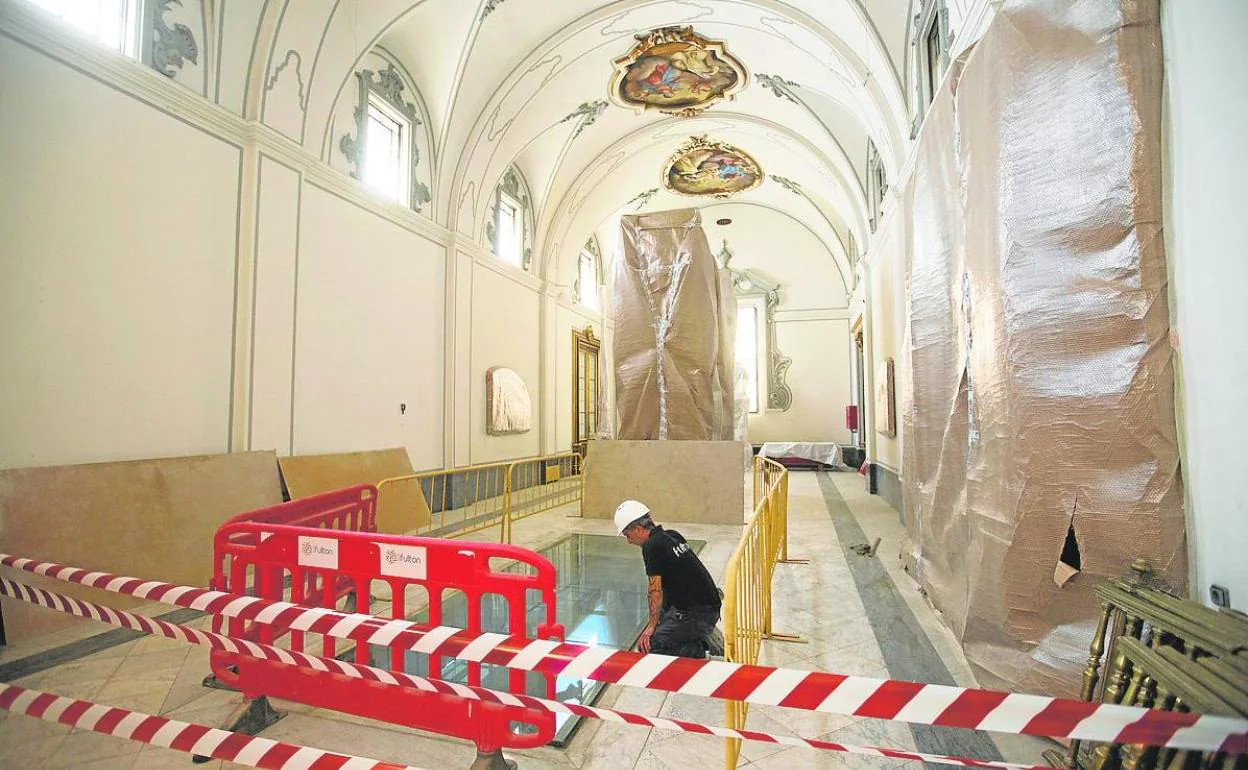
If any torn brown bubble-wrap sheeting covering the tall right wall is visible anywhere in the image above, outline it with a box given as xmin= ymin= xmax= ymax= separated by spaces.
xmin=902 ymin=0 xmax=1187 ymax=696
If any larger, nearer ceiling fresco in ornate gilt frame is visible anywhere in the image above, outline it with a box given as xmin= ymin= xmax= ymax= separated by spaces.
xmin=610 ymin=26 xmax=748 ymax=115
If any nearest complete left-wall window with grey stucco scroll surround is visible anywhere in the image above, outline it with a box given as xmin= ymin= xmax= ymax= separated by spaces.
xmin=338 ymin=61 xmax=433 ymax=211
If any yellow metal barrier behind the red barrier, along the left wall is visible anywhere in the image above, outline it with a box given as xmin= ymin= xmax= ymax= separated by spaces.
xmin=377 ymin=453 xmax=582 ymax=543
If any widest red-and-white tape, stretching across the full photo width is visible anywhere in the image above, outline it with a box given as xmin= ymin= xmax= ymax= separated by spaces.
xmin=0 ymin=554 xmax=1248 ymax=754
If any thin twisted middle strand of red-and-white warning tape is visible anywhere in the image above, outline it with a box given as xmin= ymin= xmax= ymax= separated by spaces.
xmin=0 ymin=578 xmax=1048 ymax=770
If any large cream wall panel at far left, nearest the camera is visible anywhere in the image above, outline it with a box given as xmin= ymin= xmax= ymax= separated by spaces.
xmin=0 ymin=36 xmax=241 ymax=468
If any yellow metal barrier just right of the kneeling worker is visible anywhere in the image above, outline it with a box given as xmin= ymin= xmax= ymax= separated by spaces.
xmin=724 ymin=457 xmax=801 ymax=769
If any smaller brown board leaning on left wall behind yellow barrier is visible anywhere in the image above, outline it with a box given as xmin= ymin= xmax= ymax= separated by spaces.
xmin=277 ymin=447 xmax=429 ymax=534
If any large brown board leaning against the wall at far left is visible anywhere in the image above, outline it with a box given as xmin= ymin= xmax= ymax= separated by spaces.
xmin=0 ymin=452 xmax=282 ymax=643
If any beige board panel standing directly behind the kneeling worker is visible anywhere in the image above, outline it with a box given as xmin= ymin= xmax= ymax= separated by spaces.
xmin=582 ymin=441 xmax=745 ymax=524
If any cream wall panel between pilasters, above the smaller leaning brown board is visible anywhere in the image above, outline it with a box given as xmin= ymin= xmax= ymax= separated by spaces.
xmin=293 ymin=185 xmax=446 ymax=468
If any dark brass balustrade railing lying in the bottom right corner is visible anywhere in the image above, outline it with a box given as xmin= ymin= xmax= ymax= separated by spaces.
xmin=1045 ymin=562 xmax=1248 ymax=770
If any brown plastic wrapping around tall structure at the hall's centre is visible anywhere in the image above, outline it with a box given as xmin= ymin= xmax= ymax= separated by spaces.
xmin=613 ymin=208 xmax=736 ymax=441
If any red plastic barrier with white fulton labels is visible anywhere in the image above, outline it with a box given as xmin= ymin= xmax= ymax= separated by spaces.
xmin=212 ymin=485 xmax=564 ymax=753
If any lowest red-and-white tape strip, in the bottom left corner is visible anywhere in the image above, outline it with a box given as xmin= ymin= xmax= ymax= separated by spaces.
xmin=0 ymin=683 xmax=419 ymax=770
